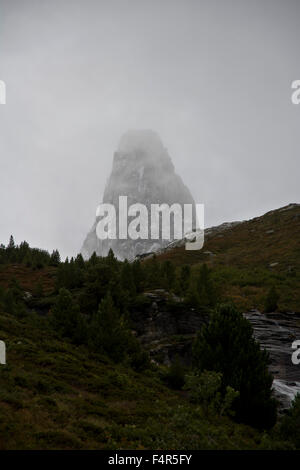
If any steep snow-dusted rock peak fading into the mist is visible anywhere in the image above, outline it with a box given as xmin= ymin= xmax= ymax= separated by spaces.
xmin=81 ymin=130 xmax=195 ymax=260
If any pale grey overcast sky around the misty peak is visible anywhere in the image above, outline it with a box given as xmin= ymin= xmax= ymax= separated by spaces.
xmin=0 ymin=0 xmax=300 ymax=256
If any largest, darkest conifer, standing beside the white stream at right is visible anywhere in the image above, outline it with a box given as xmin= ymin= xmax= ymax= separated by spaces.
xmin=193 ymin=305 xmax=276 ymax=428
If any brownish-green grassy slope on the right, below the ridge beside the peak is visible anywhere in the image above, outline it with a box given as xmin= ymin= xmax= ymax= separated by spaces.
xmin=159 ymin=205 xmax=300 ymax=312
